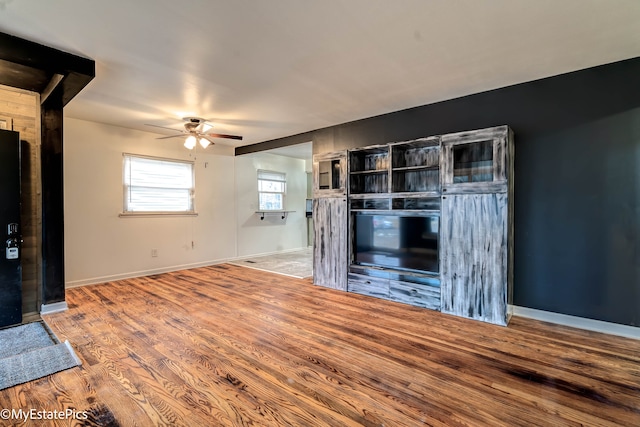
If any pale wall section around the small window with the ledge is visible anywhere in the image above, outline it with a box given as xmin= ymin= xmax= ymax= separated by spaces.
xmin=236 ymin=152 xmax=307 ymax=257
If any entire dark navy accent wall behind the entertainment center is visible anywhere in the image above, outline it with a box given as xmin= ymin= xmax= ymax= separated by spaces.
xmin=236 ymin=58 xmax=640 ymax=326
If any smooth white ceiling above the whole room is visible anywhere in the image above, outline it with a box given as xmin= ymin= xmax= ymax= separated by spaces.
xmin=0 ymin=0 xmax=640 ymax=150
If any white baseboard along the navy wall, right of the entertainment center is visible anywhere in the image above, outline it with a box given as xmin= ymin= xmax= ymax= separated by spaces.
xmin=513 ymin=306 xmax=640 ymax=339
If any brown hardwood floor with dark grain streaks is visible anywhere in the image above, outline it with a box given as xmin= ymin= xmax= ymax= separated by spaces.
xmin=0 ymin=265 xmax=640 ymax=426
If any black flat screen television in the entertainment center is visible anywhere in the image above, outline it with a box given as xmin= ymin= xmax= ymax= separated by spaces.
xmin=353 ymin=213 xmax=440 ymax=273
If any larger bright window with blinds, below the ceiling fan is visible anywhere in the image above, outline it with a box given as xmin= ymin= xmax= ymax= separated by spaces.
xmin=122 ymin=153 xmax=195 ymax=214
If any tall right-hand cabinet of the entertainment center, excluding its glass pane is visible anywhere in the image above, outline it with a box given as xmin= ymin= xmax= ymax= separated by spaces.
xmin=440 ymin=126 xmax=514 ymax=325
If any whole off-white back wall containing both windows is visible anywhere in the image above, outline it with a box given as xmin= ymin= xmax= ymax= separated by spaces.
xmin=64 ymin=118 xmax=308 ymax=286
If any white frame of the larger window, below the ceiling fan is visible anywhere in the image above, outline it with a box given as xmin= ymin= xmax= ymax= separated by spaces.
xmin=120 ymin=153 xmax=197 ymax=216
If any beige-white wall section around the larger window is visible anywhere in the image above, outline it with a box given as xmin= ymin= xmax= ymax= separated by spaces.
xmin=64 ymin=118 xmax=237 ymax=286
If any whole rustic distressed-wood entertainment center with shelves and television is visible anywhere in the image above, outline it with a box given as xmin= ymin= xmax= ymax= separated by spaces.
xmin=313 ymin=126 xmax=514 ymax=325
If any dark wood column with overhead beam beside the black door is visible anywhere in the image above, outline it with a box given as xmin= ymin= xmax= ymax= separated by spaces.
xmin=0 ymin=33 xmax=96 ymax=305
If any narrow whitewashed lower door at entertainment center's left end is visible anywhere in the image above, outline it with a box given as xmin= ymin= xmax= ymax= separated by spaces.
xmin=313 ymin=197 xmax=348 ymax=291
